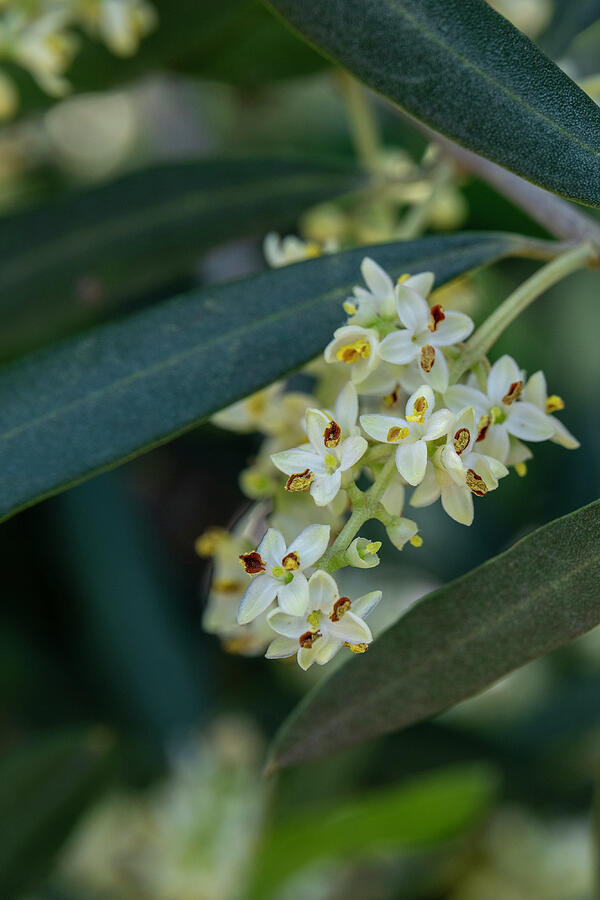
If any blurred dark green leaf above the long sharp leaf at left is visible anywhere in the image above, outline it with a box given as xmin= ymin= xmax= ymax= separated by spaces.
xmin=0 ymin=156 xmax=365 ymax=356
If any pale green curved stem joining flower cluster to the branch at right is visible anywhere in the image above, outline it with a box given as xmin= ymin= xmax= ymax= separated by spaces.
xmin=450 ymin=241 xmax=597 ymax=384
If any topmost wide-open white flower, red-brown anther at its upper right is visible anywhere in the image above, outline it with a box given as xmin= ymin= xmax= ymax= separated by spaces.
xmin=377 ymin=281 xmax=473 ymax=391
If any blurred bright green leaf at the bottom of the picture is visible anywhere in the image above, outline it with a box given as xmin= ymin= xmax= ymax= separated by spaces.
xmin=250 ymin=764 xmax=498 ymax=900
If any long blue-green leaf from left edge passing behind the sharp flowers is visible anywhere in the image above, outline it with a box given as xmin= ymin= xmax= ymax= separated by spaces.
xmin=0 ymin=232 xmax=551 ymax=518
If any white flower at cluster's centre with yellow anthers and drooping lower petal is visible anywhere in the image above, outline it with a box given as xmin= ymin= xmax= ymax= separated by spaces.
xmin=360 ymin=384 xmax=454 ymax=485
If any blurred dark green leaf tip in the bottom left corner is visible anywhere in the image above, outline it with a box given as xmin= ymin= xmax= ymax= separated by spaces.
xmin=0 ymin=731 xmax=113 ymax=900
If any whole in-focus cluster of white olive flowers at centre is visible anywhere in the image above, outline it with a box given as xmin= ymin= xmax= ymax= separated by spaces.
xmin=201 ymin=258 xmax=578 ymax=669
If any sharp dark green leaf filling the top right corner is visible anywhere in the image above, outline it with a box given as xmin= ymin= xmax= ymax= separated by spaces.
xmin=269 ymin=0 xmax=600 ymax=206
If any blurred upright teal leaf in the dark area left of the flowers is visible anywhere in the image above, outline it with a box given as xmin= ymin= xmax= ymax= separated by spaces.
xmin=54 ymin=472 xmax=208 ymax=744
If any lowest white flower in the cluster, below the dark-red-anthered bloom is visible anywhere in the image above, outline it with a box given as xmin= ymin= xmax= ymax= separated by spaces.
xmin=265 ymin=571 xmax=381 ymax=669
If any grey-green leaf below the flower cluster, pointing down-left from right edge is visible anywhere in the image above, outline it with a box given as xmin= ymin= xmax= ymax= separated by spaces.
xmin=271 ymin=501 xmax=600 ymax=768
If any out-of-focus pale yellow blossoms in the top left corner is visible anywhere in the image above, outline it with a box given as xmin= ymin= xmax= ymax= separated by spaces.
xmin=0 ymin=0 xmax=157 ymax=119
